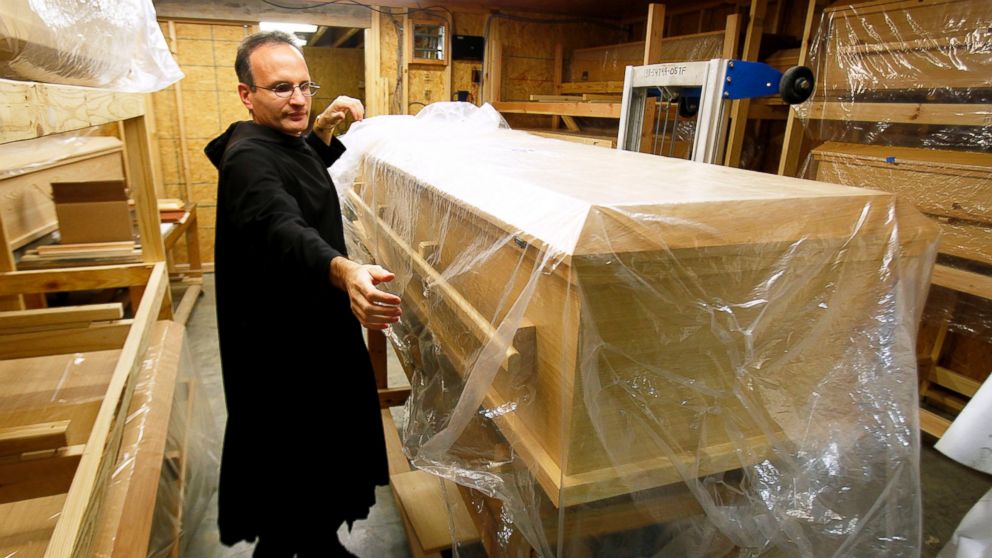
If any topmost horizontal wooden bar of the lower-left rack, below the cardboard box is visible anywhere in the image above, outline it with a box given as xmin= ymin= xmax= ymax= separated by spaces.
xmin=0 ymin=264 xmax=152 ymax=296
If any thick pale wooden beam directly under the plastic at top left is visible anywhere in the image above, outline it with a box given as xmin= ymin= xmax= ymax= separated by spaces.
xmin=0 ymin=79 xmax=145 ymax=144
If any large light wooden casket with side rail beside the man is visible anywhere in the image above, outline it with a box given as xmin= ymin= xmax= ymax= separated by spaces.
xmin=345 ymin=129 xmax=937 ymax=507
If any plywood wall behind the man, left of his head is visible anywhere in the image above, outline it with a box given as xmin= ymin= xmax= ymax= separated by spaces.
xmin=152 ymin=22 xmax=252 ymax=272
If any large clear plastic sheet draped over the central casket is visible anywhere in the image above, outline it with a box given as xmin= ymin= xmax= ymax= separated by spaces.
xmin=331 ymin=103 xmax=938 ymax=557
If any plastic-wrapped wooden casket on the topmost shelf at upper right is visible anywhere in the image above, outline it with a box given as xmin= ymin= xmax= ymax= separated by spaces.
xmin=817 ymin=0 xmax=992 ymax=94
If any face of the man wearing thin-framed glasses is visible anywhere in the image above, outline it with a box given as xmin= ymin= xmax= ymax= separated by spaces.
xmin=238 ymin=43 xmax=310 ymax=136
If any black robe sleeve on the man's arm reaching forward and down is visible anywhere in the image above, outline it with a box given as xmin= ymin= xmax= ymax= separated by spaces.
xmin=221 ymin=147 xmax=343 ymax=284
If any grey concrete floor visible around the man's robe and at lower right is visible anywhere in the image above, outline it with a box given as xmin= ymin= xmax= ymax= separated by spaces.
xmin=177 ymin=274 xmax=992 ymax=558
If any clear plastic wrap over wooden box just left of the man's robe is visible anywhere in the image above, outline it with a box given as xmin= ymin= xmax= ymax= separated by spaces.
xmin=93 ymin=321 xmax=221 ymax=558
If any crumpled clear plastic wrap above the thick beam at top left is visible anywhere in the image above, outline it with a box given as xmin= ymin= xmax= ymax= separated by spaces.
xmin=0 ymin=0 xmax=183 ymax=93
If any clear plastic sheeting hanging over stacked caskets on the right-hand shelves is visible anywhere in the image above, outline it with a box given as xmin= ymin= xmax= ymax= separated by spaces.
xmin=793 ymin=0 xmax=992 ymax=420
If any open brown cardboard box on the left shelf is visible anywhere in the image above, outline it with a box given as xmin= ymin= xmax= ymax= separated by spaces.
xmin=52 ymin=180 xmax=133 ymax=244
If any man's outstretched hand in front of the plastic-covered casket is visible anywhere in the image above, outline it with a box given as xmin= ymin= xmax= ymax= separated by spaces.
xmin=331 ymin=257 xmax=403 ymax=330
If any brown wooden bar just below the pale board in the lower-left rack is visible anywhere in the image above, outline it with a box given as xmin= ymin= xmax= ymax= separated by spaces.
xmin=0 ymin=320 xmax=132 ymax=359
